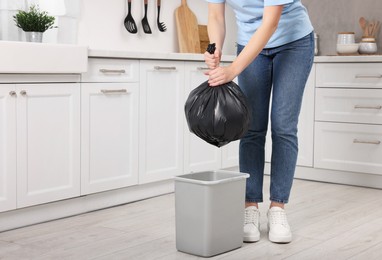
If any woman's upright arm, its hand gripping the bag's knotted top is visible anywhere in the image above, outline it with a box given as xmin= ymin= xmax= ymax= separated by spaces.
xmin=204 ymin=3 xmax=225 ymax=69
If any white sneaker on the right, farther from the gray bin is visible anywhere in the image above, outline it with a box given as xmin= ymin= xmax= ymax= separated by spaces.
xmin=268 ymin=207 xmax=292 ymax=243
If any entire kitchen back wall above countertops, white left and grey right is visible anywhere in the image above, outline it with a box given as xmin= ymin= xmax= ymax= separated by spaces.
xmin=0 ymin=0 xmax=382 ymax=55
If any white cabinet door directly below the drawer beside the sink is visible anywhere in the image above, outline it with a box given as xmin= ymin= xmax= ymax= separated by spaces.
xmin=81 ymin=83 xmax=138 ymax=194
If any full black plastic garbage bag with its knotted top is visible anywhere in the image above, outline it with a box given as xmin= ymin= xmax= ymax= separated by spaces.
xmin=185 ymin=44 xmax=251 ymax=147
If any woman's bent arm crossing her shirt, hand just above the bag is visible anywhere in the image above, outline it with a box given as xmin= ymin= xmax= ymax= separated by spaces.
xmin=207 ymin=5 xmax=283 ymax=86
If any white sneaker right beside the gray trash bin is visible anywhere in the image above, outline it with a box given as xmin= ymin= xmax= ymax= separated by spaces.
xmin=243 ymin=206 xmax=260 ymax=242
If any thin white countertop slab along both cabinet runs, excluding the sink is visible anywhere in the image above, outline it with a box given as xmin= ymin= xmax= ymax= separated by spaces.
xmin=89 ymin=49 xmax=382 ymax=63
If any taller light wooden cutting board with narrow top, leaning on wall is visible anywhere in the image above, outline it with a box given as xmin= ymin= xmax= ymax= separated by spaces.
xmin=175 ymin=0 xmax=201 ymax=53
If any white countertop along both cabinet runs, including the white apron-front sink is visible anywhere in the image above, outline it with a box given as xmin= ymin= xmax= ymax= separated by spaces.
xmin=0 ymin=41 xmax=382 ymax=73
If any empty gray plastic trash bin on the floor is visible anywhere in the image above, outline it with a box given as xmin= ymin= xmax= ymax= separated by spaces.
xmin=175 ymin=171 xmax=249 ymax=257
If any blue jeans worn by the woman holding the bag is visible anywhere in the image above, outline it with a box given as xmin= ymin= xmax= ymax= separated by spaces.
xmin=237 ymin=33 xmax=314 ymax=203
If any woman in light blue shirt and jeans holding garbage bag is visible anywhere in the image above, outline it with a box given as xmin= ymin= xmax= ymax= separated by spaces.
xmin=204 ymin=0 xmax=314 ymax=243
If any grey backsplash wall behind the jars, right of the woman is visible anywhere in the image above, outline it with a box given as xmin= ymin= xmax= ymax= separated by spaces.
xmin=302 ymin=0 xmax=382 ymax=55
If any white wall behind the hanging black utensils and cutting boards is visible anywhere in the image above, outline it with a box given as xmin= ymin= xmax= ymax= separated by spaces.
xmin=77 ymin=0 xmax=236 ymax=54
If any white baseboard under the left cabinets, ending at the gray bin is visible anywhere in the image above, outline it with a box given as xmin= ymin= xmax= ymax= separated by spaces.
xmin=0 ymin=180 xmax=174 ymax=232
